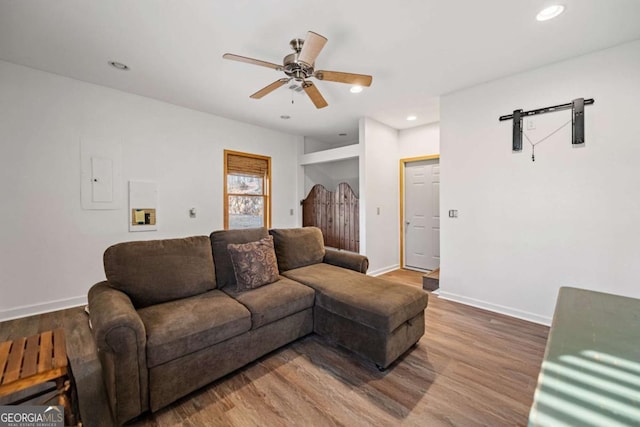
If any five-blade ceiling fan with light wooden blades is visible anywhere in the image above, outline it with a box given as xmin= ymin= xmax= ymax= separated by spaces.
xmin=222 ymin=31 xmax=373 ymax=108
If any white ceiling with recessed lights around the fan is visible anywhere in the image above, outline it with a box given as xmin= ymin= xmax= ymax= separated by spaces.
xmin=0 ymin=0 xmax=640 ymax=141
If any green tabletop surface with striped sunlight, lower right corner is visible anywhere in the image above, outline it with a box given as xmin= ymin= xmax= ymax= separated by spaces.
xmin=529 ymin=288 xmax=640 ymax=427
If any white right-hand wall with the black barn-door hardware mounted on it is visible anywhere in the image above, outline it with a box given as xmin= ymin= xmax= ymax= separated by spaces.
xmin=440 ymin=41 xmax=640 ymax=323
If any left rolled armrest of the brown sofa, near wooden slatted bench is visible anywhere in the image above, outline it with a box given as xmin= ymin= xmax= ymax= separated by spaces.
xmin=89 ymin=282 xmax=149 ymax=425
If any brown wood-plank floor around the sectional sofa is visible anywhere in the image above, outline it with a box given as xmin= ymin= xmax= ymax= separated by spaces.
xmin=0 ymin=270 xmax=548 ymax=427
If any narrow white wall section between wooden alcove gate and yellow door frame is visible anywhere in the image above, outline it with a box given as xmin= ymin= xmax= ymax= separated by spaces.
xmin=360 ymin=118 xmax=400 ymax=275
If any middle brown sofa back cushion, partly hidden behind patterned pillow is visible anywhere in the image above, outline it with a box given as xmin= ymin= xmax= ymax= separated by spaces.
xmin=210 ymin=227 xmax=269 ymax=289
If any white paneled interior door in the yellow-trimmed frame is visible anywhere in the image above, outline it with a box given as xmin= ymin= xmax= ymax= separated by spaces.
xmin=403 ymin=159 xmax=440 ymax=270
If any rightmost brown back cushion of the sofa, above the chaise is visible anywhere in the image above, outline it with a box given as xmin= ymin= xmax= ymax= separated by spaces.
xmin=269 ymin=227 xmax=324 ymax=272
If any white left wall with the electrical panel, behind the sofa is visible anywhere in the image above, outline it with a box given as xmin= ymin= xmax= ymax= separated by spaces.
xmin=0 ymin=61 xmax=302 ymax=320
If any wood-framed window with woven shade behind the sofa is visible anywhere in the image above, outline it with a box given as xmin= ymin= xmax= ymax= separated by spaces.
xmin=224 ymin=150 xmax=271 ymax=230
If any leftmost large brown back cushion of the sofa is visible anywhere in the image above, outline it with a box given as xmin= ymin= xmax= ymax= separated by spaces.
xmin=104 ymin=236 xmax=216 ymax=308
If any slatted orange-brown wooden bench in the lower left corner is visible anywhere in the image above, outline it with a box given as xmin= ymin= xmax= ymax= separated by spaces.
xmin=0 ymin=329 xmax=76 ymax=425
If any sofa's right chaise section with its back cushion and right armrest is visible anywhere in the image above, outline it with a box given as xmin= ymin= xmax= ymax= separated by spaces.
xmin=270 ymin=227 xmax=427 ymax=370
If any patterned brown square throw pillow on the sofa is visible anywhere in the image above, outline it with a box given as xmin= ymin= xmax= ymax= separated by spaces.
xmin=227 ymin=236 xmax=279 ymax=292
